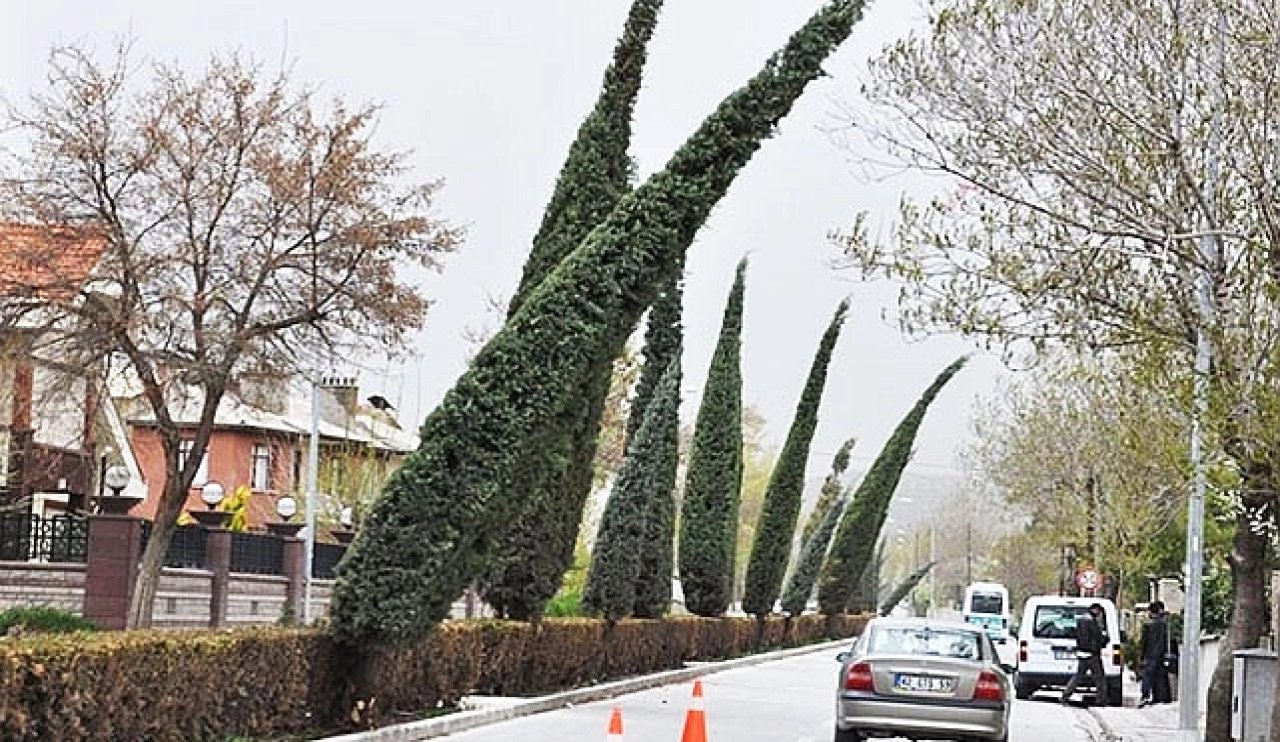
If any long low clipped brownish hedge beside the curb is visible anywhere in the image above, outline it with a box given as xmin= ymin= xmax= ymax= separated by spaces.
xmin=0 ymin=615 xmax=867 ymax=742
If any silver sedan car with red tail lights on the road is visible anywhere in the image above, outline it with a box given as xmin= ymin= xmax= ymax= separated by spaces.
xmin=836 ymin=618 xmax=1014 ymax=742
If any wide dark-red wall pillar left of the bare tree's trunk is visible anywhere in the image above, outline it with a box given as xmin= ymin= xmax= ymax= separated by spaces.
xmin=84 ymin=516 xmax=142 ymax=629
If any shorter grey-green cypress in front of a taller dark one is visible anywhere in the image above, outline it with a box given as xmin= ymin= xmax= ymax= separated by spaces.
xmin=582 ymin=358 xmax=680 ymax=620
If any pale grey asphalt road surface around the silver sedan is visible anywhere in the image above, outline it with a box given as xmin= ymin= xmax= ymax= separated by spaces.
xmin=437 ymin=642 xmax=1089 ymax=742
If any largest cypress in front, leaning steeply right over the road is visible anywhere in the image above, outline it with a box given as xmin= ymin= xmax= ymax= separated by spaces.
xmin=330 ymin=0 xmax=864 ymax=642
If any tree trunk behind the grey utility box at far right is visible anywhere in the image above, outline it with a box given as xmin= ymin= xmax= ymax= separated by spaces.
xmin=1203 ymin=503 xmax=1267 ymax=742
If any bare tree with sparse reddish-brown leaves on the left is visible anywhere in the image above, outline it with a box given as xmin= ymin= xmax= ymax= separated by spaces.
xmin=0 ymin=47 xmax=460 ymax=626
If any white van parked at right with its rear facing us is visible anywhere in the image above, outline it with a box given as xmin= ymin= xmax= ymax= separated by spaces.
xmin=1014 ymin=595 xmax=1124 ymax=706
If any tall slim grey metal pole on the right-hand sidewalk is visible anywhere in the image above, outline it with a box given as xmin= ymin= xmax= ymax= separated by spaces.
xmin=1178 ymin=6 xmax=1226 ymax=739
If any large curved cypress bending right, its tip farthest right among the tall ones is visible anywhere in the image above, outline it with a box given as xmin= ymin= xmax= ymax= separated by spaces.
xmin=818 ymin=358 xmax=966 ymax=615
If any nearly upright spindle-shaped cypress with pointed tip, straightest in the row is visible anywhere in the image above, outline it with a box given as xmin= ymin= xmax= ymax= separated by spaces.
xmin=680 ymin=257 xmax=746 ymax=617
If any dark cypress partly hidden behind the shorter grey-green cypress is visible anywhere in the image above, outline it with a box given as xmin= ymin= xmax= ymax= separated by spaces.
xmin=627 ymin=271 xmax=684 ymax=618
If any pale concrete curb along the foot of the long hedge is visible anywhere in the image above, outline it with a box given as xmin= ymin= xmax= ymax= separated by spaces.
xmin=315 ymin=637 xmax=852 ymax=742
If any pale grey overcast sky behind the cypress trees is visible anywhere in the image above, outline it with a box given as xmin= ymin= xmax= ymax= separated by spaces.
xmin=0 ymin=0 xmax=1002 ymax=473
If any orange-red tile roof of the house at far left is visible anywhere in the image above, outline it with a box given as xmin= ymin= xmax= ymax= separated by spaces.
xmin=0 ymin=221 xmax=106 ymax=301
